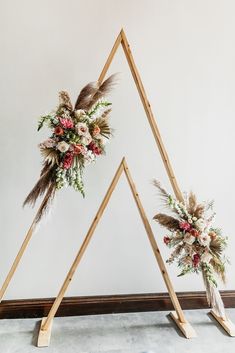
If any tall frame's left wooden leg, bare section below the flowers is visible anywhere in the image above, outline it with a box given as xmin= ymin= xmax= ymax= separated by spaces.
xmin=0 ymin=187 xmax=53 ymax=302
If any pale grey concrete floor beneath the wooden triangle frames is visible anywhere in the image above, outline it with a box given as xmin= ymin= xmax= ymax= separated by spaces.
xmin=0 ymin=309 xmax=235 ymax=353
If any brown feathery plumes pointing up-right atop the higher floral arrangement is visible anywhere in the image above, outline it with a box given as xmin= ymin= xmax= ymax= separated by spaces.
xmin=75 ymin=75 xmax=116 ymax=110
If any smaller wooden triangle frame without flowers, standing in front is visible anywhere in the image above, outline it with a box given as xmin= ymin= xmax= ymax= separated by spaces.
xmin=37 ymin=158 xmax=196 ymax=347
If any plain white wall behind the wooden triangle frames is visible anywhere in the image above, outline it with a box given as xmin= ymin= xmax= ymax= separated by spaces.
xmin=0 ymin=0 xmax=235 ymax=299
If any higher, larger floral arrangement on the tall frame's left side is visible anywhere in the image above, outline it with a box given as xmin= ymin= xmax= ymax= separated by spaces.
xmin=24 ymin=75 xmax=115 ymax=220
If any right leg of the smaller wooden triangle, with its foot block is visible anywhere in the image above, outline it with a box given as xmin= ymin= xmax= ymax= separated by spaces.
xmin=123 ymin=159 xmax=197 ymax=338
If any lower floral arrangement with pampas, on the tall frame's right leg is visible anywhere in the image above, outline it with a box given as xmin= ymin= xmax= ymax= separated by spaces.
xmin=154 ymin=181 xmax=228 ymax=316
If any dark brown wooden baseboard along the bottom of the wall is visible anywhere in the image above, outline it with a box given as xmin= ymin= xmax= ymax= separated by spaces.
xmin=0 ymin=291 xmax=235 ymax=319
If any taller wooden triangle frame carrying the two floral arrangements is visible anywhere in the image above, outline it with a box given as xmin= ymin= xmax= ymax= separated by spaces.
xmin=0 ymin=29 xmax=235 ymax=342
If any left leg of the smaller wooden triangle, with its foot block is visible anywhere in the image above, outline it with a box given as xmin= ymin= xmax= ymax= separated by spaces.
xmin=37 ymin=161 xmax=123 ymax=347
